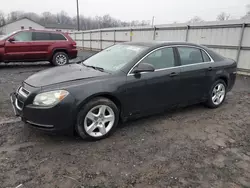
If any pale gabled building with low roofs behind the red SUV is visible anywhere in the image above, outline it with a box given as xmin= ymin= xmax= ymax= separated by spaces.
xmin=0 ymin=17 xmax=77 ymax=35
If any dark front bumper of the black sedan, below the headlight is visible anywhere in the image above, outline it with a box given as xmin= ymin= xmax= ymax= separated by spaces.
xmin=10 ymin=93 xmax=76 ymax=132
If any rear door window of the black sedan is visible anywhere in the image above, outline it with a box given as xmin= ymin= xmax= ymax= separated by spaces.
xmin=177 ymin=47 xmax=203 ymax=65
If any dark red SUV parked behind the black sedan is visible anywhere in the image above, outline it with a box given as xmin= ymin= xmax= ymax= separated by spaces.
xmin=0 ymin=30 xmax=77 ymax=66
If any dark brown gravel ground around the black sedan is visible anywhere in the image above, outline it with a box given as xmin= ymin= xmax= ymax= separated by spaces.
xmin=0 ymin=55 xmax=250 ymax=188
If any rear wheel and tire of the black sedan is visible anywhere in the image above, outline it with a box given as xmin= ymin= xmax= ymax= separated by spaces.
xmin=206 ymin=79 xmax=227 ymax=108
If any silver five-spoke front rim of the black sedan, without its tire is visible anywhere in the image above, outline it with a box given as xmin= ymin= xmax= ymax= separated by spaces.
xmin=84 ymin=105 xmax=115 ymax=137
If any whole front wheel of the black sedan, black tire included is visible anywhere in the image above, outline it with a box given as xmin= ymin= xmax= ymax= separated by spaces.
xmin=76 ymin=97 xmax=119 ymax=140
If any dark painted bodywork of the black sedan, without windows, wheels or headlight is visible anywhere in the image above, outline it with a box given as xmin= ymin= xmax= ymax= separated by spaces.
xmin=12 ymin=43 xmax=236 ymax=130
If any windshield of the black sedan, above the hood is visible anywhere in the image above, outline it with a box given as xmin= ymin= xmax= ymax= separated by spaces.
xmin=84 ymin=44 xmax=146 ymax=72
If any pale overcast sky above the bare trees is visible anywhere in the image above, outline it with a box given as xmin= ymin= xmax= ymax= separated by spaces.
xmin=0 ymin=0 xmax=250 ymax=24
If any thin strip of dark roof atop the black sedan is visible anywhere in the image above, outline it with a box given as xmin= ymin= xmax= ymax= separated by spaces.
xmin=124 ymin=41 xmax=204 ymax=48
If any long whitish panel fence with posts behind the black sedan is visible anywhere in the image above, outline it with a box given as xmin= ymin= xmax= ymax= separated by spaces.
xmin=70 ymin=20 xmax=250 ymax=73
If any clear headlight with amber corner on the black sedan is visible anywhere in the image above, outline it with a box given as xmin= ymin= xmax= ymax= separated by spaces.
xmin=33 ymin=90 xmax=69 ymax=106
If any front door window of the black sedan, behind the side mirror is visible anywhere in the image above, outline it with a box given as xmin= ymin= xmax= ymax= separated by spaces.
xmin=141 ymin=48 xmax=175 ymax=70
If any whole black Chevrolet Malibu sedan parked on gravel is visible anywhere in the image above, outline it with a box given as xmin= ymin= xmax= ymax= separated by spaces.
xmin=11 ymin=42 xmax=236 ymax=140
